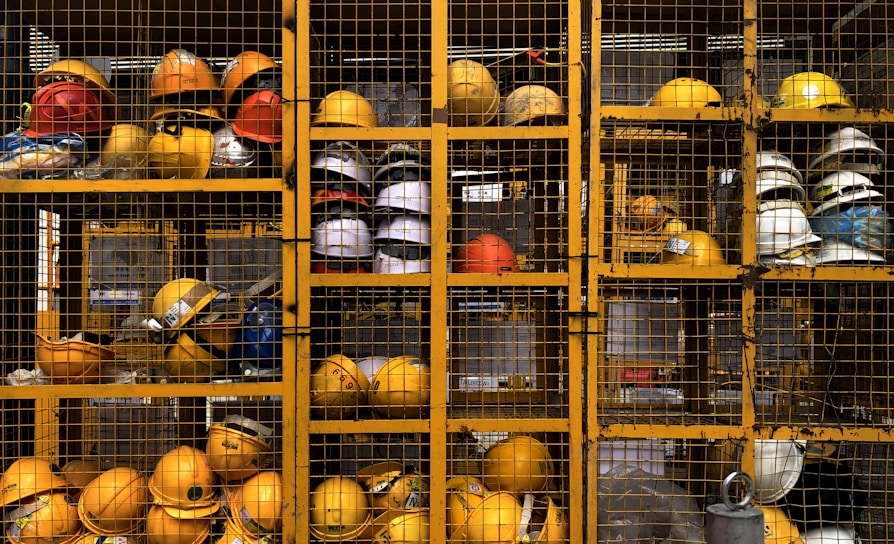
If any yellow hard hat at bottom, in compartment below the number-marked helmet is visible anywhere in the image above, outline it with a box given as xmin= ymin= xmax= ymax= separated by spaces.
xmin=310 ymin=476 xmax=372 ymax=542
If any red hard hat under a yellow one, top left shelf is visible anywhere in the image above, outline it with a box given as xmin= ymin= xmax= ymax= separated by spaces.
xmin=22 ymin=81 xmax=115 ymax=136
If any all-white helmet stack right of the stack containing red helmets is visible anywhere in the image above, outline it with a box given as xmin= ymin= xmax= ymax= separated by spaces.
xmin=373 ymin=143 xmax=431 ymax=274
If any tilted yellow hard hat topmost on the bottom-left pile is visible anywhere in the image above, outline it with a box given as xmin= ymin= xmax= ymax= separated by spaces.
xmin=205 ymin=414 xmax=273 ymax=481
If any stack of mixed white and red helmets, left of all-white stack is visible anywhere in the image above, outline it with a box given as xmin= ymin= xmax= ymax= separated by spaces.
xmin=311 ymin=141 xmax=373 ymax=274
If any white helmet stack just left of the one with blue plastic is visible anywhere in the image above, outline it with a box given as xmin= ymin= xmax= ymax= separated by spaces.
xmin=756 ymin=150 xmax=820 ymax=266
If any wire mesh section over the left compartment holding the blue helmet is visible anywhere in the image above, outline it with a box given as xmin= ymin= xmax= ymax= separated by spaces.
xmin=4 ymin=193 xmax=282 ymax=383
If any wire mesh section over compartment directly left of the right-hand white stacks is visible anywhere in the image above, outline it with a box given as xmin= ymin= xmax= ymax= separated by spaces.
xmin=600 ymin=122 xmax=741 ymax=265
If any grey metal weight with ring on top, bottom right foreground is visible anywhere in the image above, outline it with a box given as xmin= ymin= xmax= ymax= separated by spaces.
xmin=705 ymin=472 xmax=764 ymax=544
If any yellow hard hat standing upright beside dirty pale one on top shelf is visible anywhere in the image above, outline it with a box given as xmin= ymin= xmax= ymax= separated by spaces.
xmin=447 ymin=59 xmax=500 ymax=127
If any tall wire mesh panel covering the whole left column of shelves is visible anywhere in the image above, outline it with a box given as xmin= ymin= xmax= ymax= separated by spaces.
xmin=0 ymin=4 xmax=294 ymax=544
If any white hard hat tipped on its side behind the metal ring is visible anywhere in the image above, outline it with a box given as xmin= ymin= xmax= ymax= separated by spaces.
xmin=754 ymin=439 xmax=807 ymax=504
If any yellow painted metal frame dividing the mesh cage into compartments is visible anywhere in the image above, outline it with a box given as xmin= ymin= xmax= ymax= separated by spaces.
xmin=2 ymin=0 xmax=894 ymax=544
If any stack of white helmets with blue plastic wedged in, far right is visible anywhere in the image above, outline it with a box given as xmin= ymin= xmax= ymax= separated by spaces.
xmin=808 ymin=127 xmax=894 ymax=266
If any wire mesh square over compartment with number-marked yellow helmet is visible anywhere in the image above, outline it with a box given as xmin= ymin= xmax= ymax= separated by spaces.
xmin=310 ymin=287 xmax=432 ymax=420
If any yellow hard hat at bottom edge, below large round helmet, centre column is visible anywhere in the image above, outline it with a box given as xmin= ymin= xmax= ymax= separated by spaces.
xmin=450 ymin=491 xmax=523 ymax=544
